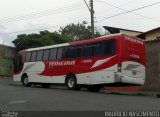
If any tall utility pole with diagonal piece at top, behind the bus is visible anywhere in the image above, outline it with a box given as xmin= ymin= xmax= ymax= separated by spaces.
xmin=84 ymin=0 xmax=94 ymax=38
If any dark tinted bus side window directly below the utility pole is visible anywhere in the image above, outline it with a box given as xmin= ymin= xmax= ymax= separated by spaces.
xmin=83 ymin=45 xmax=93 ymax=57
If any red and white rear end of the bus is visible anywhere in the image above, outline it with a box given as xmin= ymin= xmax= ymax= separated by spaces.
xmin=118 ymin=35 xmax=146 ymax=85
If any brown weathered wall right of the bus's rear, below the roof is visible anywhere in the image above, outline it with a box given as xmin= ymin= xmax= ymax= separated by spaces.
xmin=142 ymin=41 xmax=160 ymax=91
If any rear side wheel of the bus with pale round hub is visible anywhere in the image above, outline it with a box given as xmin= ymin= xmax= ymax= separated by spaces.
xmin=66 ymin=74 xmax=81 ymax=91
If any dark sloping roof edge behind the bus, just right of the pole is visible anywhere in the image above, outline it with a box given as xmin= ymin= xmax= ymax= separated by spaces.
xmin=103 ymin=26 xmax=143 ymax=34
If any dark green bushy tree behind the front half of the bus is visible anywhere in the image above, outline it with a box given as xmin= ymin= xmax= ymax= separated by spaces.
xmin=12 ymin=31 xmax=73 ymax=51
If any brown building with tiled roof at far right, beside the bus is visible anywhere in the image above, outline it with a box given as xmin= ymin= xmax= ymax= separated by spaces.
xmin=137 ymin=27 xmax=160 ymax=91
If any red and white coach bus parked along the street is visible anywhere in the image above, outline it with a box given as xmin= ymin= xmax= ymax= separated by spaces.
xmin=13 ymin=33 xmax=146 ymax=92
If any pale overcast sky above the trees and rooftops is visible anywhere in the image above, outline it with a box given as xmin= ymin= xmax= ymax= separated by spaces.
xmin=0 ymin=0 xmax=160 ymax=46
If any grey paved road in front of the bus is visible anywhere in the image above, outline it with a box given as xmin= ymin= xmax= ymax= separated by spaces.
xmin=0 ymin=79 xmax=160 ymax=111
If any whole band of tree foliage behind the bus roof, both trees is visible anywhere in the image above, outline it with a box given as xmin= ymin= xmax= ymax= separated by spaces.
xmin=12 ymin=21 xmax=101 ymax=51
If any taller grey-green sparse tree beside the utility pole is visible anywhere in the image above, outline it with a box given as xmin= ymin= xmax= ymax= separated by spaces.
xmin=59 ymin=21 xmax=101 ymax=40
